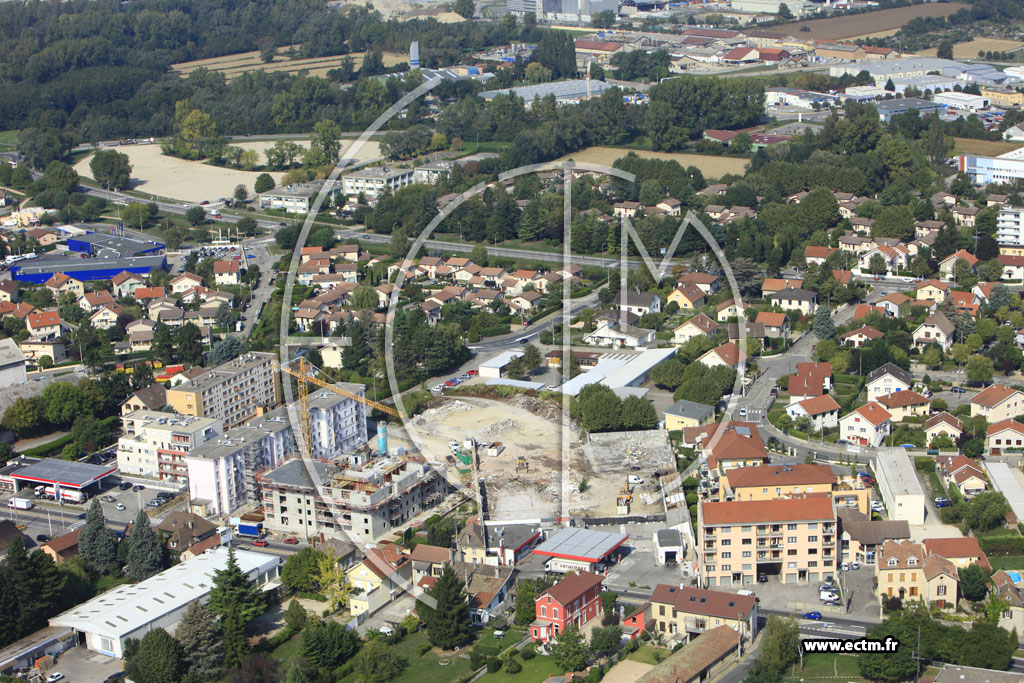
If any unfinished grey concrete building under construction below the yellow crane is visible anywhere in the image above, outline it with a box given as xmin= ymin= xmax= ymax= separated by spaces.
xmin=256 ymin=451 xmax=449 ymax=543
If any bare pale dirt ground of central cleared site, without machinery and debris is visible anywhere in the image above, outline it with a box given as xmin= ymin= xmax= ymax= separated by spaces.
xmin=410 ymin=395 xmax=668 ymax=519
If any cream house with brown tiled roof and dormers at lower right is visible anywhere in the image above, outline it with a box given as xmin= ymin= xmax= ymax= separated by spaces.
xmin=874 ymin=541 xmax=959 ymax=609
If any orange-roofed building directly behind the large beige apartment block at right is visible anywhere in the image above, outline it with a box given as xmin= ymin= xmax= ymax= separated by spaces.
xmin=719 ymin=464 xmax=871 ymax=514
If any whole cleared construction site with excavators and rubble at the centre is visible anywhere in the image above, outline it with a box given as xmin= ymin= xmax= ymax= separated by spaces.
xmin=409 ymin=394 xmax=674 ymax=521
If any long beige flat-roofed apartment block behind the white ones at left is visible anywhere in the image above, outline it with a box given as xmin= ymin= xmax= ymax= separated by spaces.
xmin=167 ymin=351 xmax=281 ymax=429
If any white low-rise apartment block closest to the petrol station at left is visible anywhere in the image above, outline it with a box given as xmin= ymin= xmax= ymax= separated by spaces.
xmin=118 ymin=410 xmax=224 ymax=485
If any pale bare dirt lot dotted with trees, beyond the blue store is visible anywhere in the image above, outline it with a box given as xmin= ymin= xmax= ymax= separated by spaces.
xmin=75 ymin=140 xmax=380 ymax=202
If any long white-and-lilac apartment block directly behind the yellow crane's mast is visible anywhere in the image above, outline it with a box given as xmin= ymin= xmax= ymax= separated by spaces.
xmin=186 ymin=384 xmax=367 ymax=516
